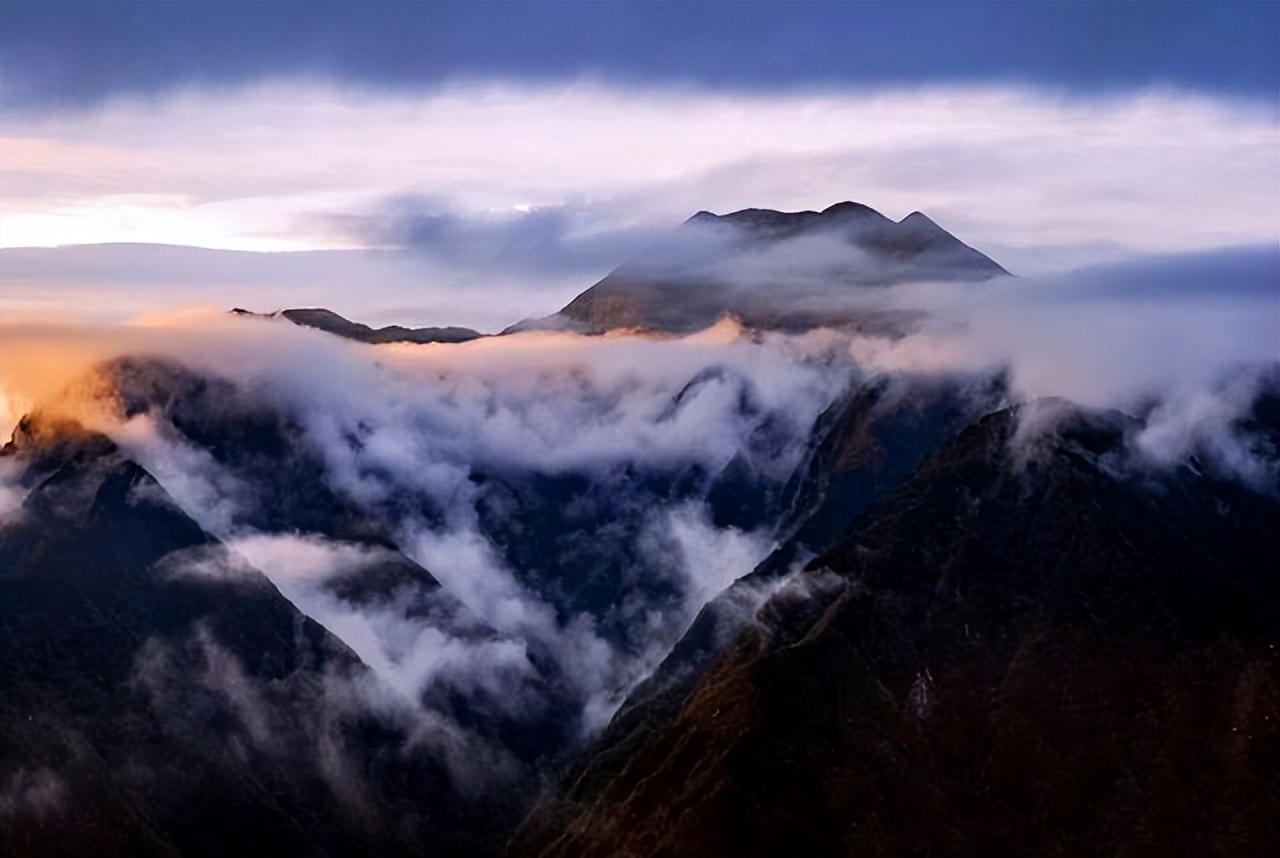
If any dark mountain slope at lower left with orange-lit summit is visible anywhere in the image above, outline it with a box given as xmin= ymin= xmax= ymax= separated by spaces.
xmin=0 ymin=415 xmax=515 ymax=855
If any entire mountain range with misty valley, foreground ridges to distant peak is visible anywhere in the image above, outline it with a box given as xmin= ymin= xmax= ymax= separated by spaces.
xmin=0 ymin=202 xmax=1280 ymax=858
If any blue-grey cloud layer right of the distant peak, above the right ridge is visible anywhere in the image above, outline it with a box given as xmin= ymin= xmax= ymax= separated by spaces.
xmin=851 ymin=246 xmax=1280 ymax=407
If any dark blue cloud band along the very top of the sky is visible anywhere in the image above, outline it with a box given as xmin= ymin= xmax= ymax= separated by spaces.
xmin=0 ymin=3 xmax=1280 ymax=109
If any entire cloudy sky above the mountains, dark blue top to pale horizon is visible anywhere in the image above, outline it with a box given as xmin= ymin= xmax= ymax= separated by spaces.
xmin=0 ymin=3 xmax=1280 ymax=329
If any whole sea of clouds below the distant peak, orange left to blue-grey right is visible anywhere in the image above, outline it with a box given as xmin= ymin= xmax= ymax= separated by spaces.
xmin=0 ymin=240 xmax=1280 ymax=777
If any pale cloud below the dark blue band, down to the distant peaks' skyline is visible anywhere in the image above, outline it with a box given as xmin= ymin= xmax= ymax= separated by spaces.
xmin=0 ymin=82 xmax=1280 ymax=329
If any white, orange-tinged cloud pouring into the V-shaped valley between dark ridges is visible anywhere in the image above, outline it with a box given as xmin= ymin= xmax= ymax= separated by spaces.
xmin=0 ymin=312 xmax=854 ymax=730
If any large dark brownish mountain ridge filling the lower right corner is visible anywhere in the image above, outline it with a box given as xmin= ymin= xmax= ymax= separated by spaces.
xmin=509 ymin=393 xmax=1280 ymax=857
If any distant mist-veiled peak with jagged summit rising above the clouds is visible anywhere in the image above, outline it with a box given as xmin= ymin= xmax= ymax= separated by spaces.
xmin=517 ymin=202 xmax=1009 ymax=336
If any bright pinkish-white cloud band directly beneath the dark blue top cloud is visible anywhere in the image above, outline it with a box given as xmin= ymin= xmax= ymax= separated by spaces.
xmin=0 ymin=82 xmax=1280 ymax=266
